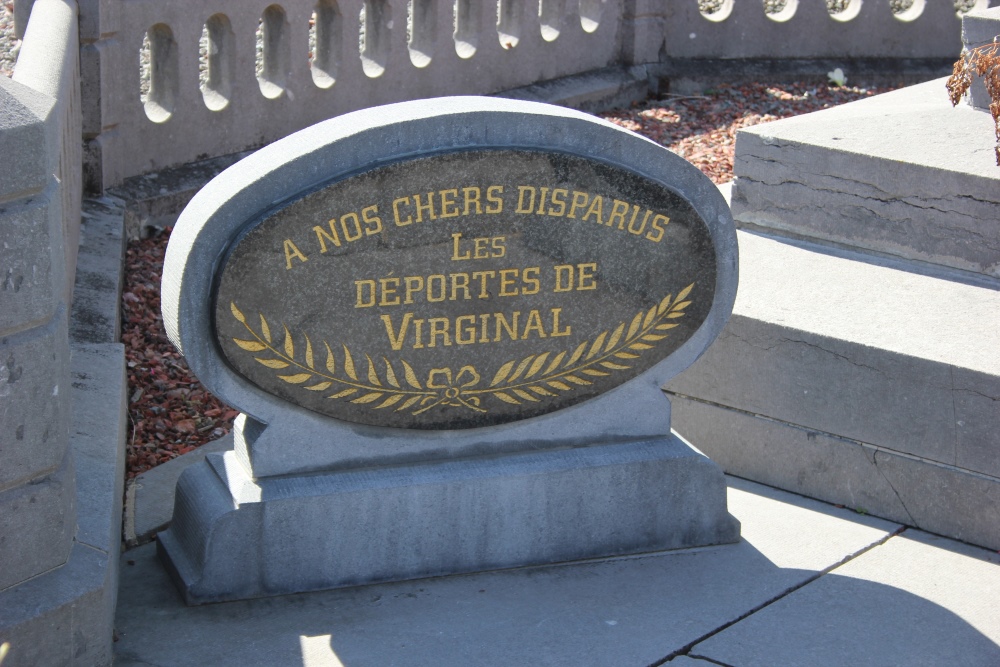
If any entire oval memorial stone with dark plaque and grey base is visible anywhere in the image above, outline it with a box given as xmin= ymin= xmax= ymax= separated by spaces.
xmin=154 ymin=98 xmax=739 ymax=603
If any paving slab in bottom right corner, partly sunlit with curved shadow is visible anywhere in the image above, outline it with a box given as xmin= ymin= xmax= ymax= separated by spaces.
xmin=690 ymin=530 xmax=1000 ymax=667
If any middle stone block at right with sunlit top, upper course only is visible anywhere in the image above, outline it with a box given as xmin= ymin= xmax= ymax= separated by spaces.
xmin=667 ymin=232 xmax=1000 ymax=474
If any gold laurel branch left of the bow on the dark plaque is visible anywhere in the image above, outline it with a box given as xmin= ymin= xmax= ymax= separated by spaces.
xmin=229 ymin=302 xmax=441 ymax=412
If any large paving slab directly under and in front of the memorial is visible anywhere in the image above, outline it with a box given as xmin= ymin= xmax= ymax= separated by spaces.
xmin=115 ymin=478 xmax=899 ymax=667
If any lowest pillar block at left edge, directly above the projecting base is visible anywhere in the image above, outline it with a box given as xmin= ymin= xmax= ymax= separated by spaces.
xmin=0 ymin=454 xmax=76 ymax=590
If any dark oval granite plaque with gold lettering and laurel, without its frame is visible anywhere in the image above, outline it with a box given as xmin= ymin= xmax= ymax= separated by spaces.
xmin=214 ymin=150 xmax=716 ymax=429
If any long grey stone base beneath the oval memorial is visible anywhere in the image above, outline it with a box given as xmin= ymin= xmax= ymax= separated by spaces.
xmin=159 ymin=435 xmax=739 ymax=604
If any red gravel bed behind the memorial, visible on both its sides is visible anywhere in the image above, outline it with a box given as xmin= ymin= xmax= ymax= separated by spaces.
xmin=122 ymin=83 xmax=890 ymax=477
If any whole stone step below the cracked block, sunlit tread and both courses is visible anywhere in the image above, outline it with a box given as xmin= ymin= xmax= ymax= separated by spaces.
xmin=667 ymin=231 xmax=1000 ymax=549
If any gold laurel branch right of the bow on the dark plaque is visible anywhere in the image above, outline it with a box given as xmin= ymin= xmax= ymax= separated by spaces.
xmin=463 ymin=283 xmax=695 ymax=405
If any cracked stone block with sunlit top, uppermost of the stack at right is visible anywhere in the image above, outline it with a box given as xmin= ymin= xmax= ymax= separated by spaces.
xmin=732 ymin=80 xmax=1000 ymax=279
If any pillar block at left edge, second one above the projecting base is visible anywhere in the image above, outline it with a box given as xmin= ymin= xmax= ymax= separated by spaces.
xmin=0 ymin=311 xmax=70 ymax=489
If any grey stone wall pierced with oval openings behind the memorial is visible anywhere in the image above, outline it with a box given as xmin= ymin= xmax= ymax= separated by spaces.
xmin=58 ymin=0 xmax=989 ymax=191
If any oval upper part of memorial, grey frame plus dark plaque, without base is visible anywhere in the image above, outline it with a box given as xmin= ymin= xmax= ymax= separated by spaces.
xmin=163 ymin=98 xmax=737 ymax=438
